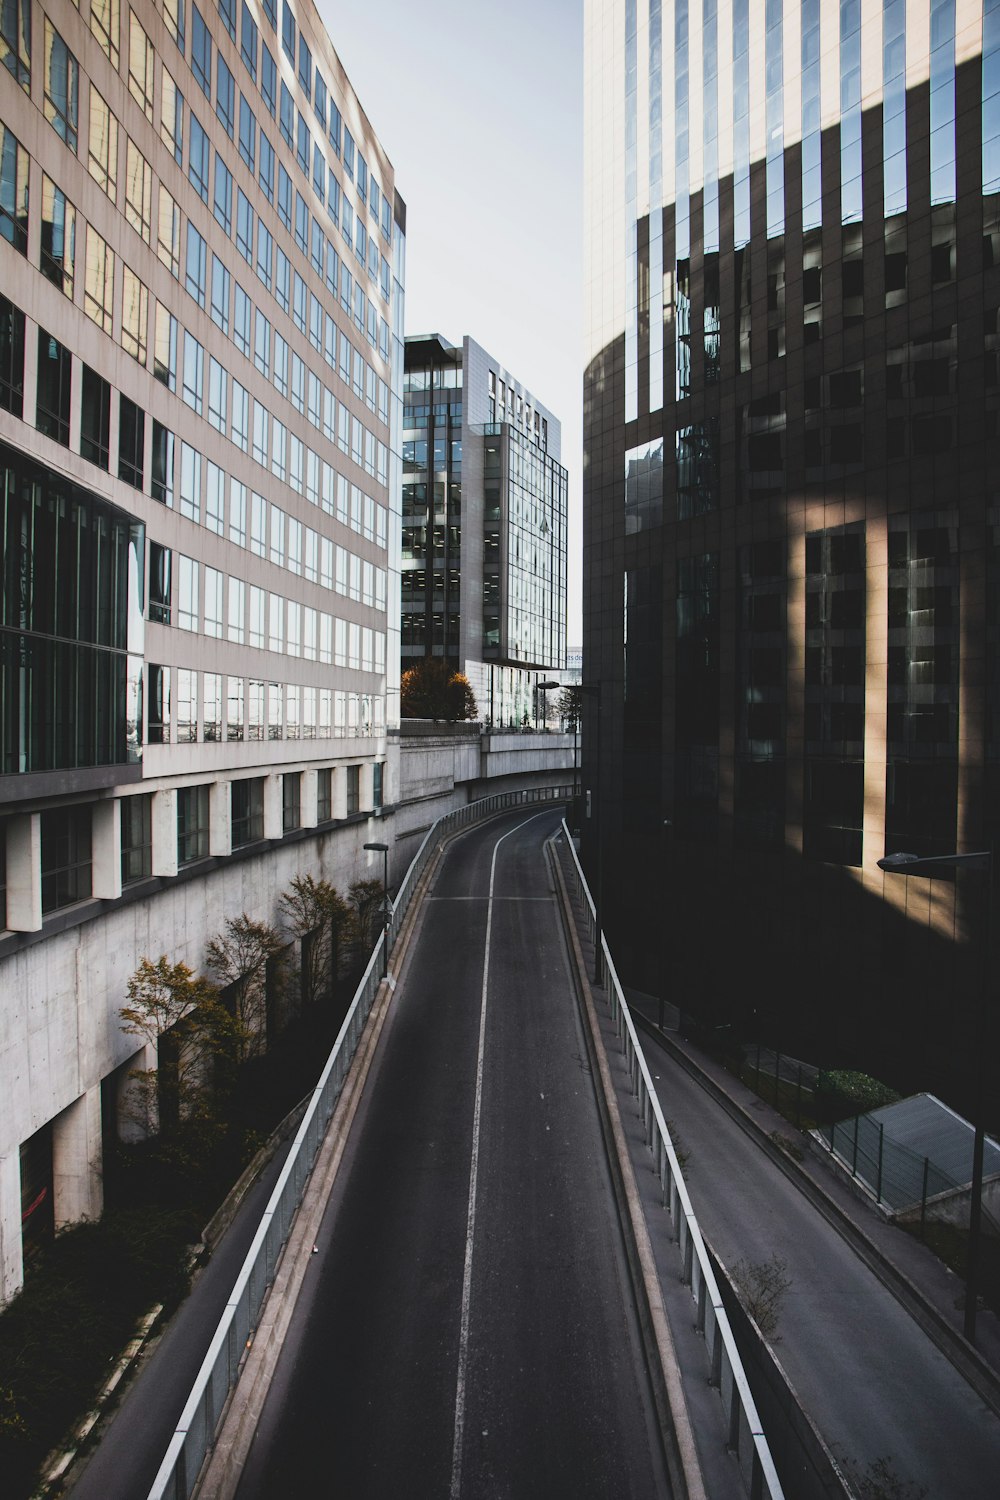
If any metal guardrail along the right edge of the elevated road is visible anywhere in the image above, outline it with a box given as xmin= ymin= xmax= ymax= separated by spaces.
xmin=562 ymin=821 xmax=784 ymax=1500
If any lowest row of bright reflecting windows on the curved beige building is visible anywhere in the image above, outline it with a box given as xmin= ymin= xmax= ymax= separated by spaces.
xmin=145 ymin=662 xmax=385 ymax=746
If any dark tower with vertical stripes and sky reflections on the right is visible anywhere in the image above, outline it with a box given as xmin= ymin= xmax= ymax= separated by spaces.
xmin=585 ymin=0 xmax=1000 ymax=1098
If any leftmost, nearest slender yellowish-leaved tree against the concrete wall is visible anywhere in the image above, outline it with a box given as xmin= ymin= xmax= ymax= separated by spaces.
xmin=118 ymin=954 xmax=238 ymax=1134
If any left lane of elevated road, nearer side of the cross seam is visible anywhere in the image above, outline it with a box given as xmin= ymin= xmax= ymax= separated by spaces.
xmin=238 ymin=876 xmax=497 ymax=1500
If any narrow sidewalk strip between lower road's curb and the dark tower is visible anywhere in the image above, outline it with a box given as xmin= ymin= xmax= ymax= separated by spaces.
xmin=627 ymin=990 xmax=1000 ymax=1413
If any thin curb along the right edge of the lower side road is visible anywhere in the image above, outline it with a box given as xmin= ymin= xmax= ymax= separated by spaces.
xmin=633 ymin=1011 xmax=1000 ymax=1416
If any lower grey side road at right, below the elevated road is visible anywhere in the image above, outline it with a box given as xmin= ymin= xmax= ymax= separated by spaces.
xmin=643 ymin=1038 xmax=1000 ymax=1500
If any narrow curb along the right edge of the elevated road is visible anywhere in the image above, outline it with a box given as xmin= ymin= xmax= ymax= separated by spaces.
xmin=546 ymin=834 xmax=708 ymax=1500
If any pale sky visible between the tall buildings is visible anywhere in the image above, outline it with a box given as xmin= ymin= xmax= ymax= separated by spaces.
xmin=316 ymin=0 xmax=583 ymax=647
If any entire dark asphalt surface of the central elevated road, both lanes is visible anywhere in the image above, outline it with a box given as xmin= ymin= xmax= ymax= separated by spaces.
xmin=238 ymin=813 xmax=670 ymax=1500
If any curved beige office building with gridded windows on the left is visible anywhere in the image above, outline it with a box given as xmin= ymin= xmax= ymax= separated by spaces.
xmin=0 ymin=0 xmax=405 ymax=1298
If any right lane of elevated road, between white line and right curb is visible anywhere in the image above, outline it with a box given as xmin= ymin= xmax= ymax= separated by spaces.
xmin=462 ymin=825 xmax=669 ymax=1500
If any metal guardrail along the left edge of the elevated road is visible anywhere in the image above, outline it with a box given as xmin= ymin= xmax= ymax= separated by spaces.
xmin=148 ymin=786 xmax=573 ymax=1500
